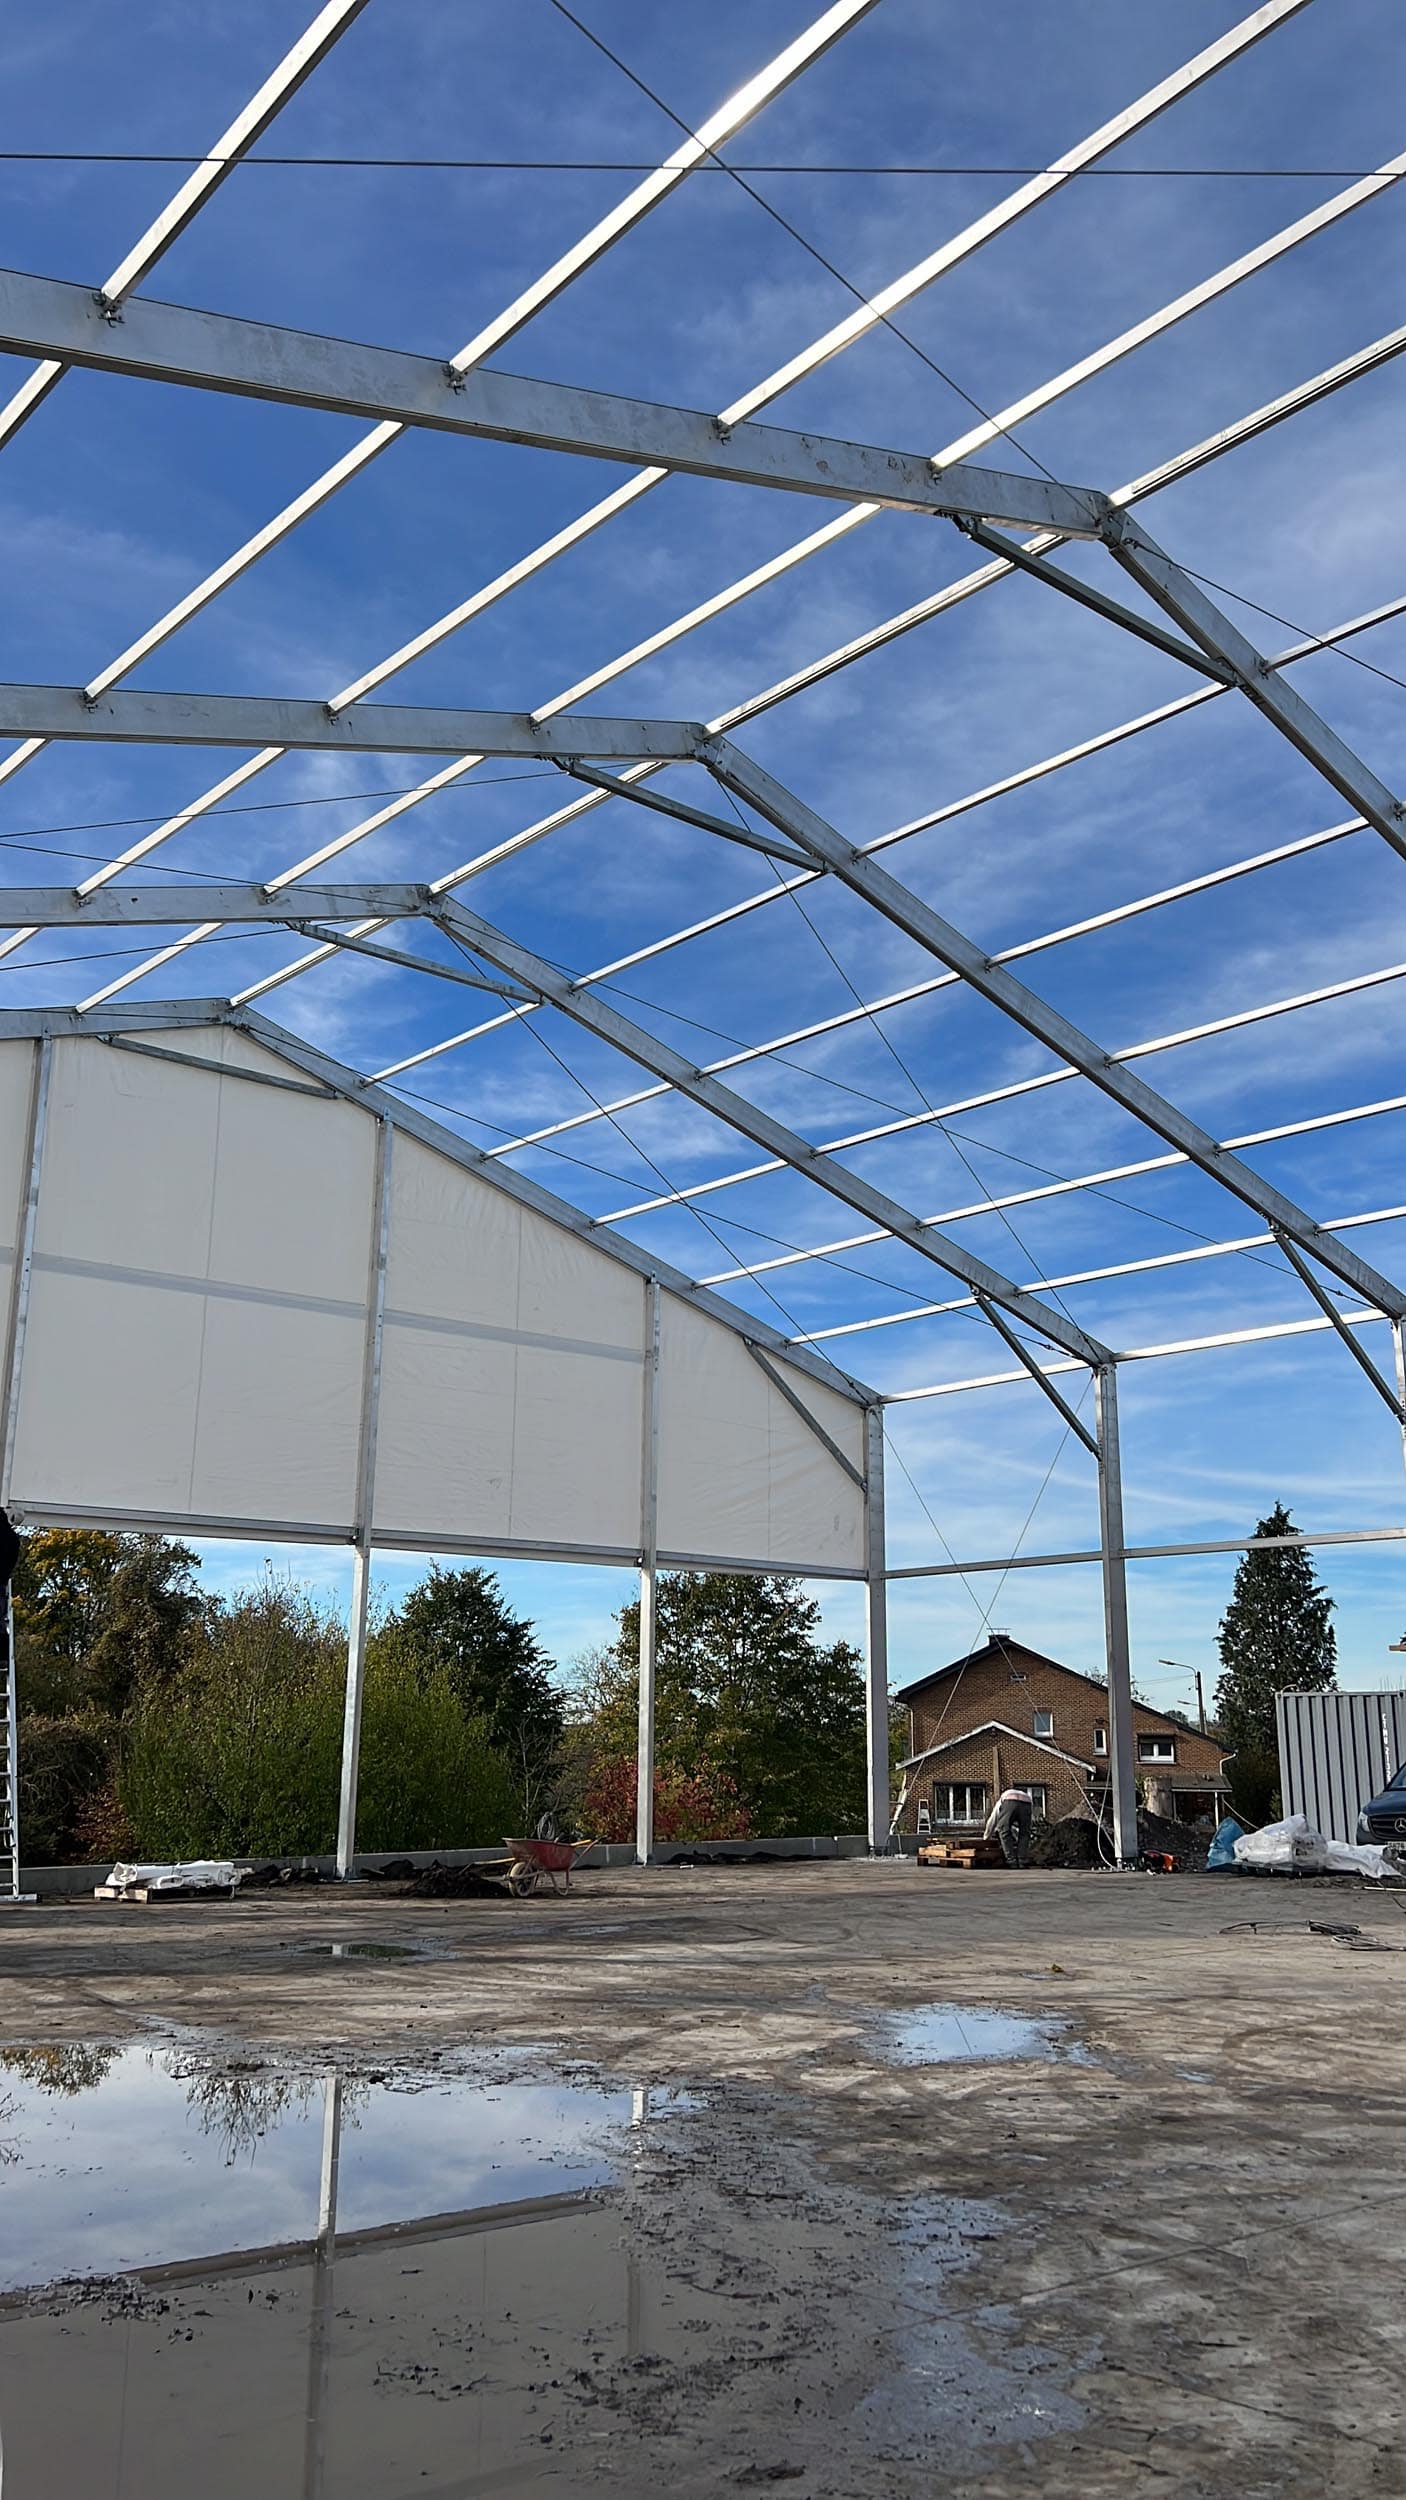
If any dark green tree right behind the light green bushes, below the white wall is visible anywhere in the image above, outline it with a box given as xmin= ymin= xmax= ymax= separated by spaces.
xmin=368 ymin=1563 xmax=565 ymax=1828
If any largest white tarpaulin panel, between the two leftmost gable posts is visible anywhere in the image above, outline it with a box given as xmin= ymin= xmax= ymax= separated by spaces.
xmin=5 ymin=1040 xmax=375 ymax=1528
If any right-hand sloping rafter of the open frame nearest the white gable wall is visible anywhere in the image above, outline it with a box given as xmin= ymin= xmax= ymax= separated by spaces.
xmin=427 ymin=898 xmax=1111 ymax=1368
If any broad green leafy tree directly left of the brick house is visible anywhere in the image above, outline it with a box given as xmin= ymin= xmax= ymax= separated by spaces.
xmin=568 ymin=1573 xmax=866 ymax=1838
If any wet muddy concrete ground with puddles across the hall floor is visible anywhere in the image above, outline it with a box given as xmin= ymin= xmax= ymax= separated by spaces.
xmin=0 ymin=1860 xmax=1406 ymax=2500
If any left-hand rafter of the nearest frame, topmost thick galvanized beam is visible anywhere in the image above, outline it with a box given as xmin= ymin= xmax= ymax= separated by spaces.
xmin=0 ymin=270 xmax=1105 ymax=535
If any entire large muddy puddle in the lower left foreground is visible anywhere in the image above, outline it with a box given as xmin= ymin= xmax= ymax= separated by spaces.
xmin=0 ymin=2048 xmax=1078 ymax=2500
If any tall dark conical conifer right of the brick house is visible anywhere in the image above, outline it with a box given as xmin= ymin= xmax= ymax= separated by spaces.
xmin=1216 ymin=1503 xmax=1338 ymax=1813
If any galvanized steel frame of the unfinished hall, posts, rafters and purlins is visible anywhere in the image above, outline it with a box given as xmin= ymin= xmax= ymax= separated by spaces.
xmin=0 ymin=0 xmax=1406 ymax=1873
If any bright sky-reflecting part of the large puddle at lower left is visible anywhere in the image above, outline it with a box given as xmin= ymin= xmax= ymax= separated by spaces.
xmin=0 ymin=2048 xmax=630 ymax=2290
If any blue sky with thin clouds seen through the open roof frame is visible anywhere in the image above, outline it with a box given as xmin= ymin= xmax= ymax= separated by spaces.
xmin=0 ymin=0 xmax=1406 ymax=1700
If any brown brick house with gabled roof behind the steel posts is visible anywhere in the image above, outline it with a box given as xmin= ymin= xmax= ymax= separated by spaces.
xmin=896 ymin=1633 xmax=1228 ymax=1833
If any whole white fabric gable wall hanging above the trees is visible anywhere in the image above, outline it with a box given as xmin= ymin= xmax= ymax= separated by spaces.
xmin=0 ymin=1028 xmax=866 ymax=1575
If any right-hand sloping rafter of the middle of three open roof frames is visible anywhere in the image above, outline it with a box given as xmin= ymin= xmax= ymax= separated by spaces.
xmin=706 ymin=740 xmax=1406 ymax=1318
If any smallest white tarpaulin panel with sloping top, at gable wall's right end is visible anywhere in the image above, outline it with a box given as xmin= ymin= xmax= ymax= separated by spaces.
xmin=658 ymin=1293 xmax=863 ymax=1570
